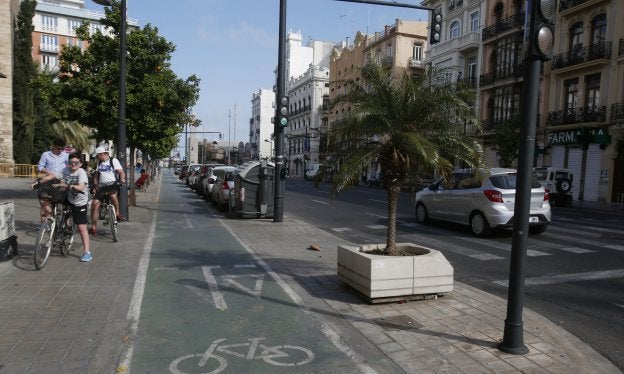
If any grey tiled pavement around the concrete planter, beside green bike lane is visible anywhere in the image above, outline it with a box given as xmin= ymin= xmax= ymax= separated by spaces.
xmin=222 ymin=216 xmax=620 ymax=374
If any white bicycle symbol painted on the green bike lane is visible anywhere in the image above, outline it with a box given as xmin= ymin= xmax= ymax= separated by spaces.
xmin=169 ymin=338 xmax=314 ymax=374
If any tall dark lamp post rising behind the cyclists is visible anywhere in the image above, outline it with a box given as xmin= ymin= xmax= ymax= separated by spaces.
xmin=93 ymin=0 xmax=130 ymax=219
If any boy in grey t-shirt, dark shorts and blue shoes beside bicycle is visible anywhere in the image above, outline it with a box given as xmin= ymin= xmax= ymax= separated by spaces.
xmin=33 ymin=152 xmax=93 ymax=262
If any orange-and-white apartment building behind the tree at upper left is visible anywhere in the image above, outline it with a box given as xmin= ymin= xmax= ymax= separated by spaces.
xmin=32 ymin=0 xmax=137 ymax=71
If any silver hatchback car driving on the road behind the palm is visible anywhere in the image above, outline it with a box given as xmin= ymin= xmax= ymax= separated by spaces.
xmin=415 ymin=169 xmax=551 ymax=237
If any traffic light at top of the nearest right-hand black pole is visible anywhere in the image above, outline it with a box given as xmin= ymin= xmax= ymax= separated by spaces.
xmin=524 ymin=0 xmax=557 ymax=61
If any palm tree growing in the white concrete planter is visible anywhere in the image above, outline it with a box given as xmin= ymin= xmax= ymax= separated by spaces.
xmin=328 ymin=63 xmax=483 ymax=255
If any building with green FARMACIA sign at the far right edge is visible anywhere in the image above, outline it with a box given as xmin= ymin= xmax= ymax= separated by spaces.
xmin=538 ymin=0 xmax=624 ymax=202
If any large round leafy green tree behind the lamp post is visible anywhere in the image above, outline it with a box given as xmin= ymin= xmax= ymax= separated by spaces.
xmin=57 ymin=2 xmax=199 ymax=158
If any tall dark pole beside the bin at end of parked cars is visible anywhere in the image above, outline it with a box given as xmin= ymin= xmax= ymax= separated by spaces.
xmin=273 ymin=0 xmax=286 ymax=222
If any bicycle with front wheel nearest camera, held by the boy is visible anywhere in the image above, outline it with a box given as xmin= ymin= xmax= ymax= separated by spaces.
xmin=33 ymin=181 xmax=78 ymax=270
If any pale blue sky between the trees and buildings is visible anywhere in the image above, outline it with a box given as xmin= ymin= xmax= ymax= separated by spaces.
xmin=85 ymin=0 xmax=428 ymax=150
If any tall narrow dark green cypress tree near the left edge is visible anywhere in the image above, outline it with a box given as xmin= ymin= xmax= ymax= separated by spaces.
xmin=13 ymin=0 xmax=37 ymax=164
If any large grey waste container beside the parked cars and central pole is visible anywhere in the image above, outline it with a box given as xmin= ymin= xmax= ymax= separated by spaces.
xmin=230 ymin=160 xmax=275 ymax=218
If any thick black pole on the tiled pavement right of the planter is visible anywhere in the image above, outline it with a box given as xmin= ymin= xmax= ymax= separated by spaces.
xmin=498 ymin=53 xmax=541 ymax=354
